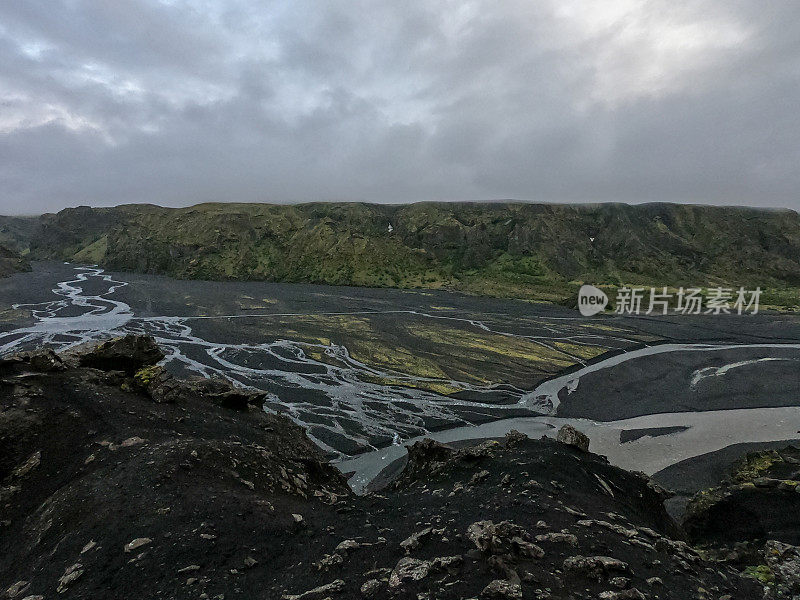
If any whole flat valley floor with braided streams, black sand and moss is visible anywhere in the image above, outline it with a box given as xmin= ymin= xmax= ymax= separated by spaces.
xmin=0 ymin=263 xmax=800 ymax=487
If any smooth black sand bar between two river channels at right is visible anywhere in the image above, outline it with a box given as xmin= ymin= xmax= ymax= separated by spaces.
xmin=557 ymin=347 xmax=800 ymax=421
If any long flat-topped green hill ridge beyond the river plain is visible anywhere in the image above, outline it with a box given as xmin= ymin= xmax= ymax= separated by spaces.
xmin=14 ymin=203 xmax=800 ymax=300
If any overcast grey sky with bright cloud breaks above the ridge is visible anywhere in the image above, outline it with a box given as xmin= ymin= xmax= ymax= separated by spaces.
xmin=0 ymin=0 xmax=800 ymax=214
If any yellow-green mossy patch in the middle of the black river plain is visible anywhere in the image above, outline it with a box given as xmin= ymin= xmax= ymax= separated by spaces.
xmin=212 ymin=313 xmax=600 ymax=394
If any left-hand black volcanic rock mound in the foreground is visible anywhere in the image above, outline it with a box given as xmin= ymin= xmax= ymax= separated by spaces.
xmin=0 ymin=340 xmax=350 ymax=598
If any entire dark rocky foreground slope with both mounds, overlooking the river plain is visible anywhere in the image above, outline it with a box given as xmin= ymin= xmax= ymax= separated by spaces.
xmin=0 ymin=338 xmax=788 ymax=600
